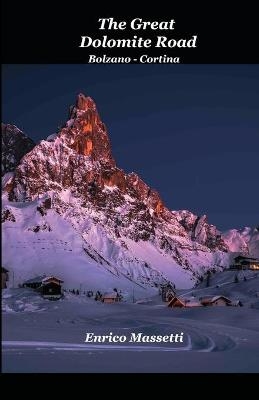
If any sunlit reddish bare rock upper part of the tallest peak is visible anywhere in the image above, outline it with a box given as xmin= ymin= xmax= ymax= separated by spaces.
xmin=6 ymin=94 xmax=186 ymax=240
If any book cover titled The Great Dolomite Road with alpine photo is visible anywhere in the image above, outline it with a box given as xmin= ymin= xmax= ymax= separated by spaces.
xmin=2 ymin=2 xmax=259 ymax=373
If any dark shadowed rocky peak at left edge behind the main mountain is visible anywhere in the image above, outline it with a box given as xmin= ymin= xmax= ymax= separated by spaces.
xmin=1 ymin=124 xmax=35 ymax=176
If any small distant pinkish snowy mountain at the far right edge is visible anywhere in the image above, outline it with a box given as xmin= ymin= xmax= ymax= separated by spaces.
xmin=223 ymin=226 xmax=259 ymax=258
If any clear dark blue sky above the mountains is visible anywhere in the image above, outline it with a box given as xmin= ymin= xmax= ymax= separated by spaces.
xmin=2 ymin=64 xmax=259 ymax=230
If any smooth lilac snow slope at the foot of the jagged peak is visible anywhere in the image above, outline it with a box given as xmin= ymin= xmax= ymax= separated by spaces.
xmin=2 ymin=194 xmax=201 ymax=290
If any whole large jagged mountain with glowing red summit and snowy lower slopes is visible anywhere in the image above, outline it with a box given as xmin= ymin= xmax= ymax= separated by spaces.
xmin=2 ymin=94 xmax=244 ymax=289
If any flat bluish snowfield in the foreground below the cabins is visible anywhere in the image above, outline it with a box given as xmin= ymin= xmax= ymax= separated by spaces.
xmin=2 ymin=271 xmax=259 ymax=373
